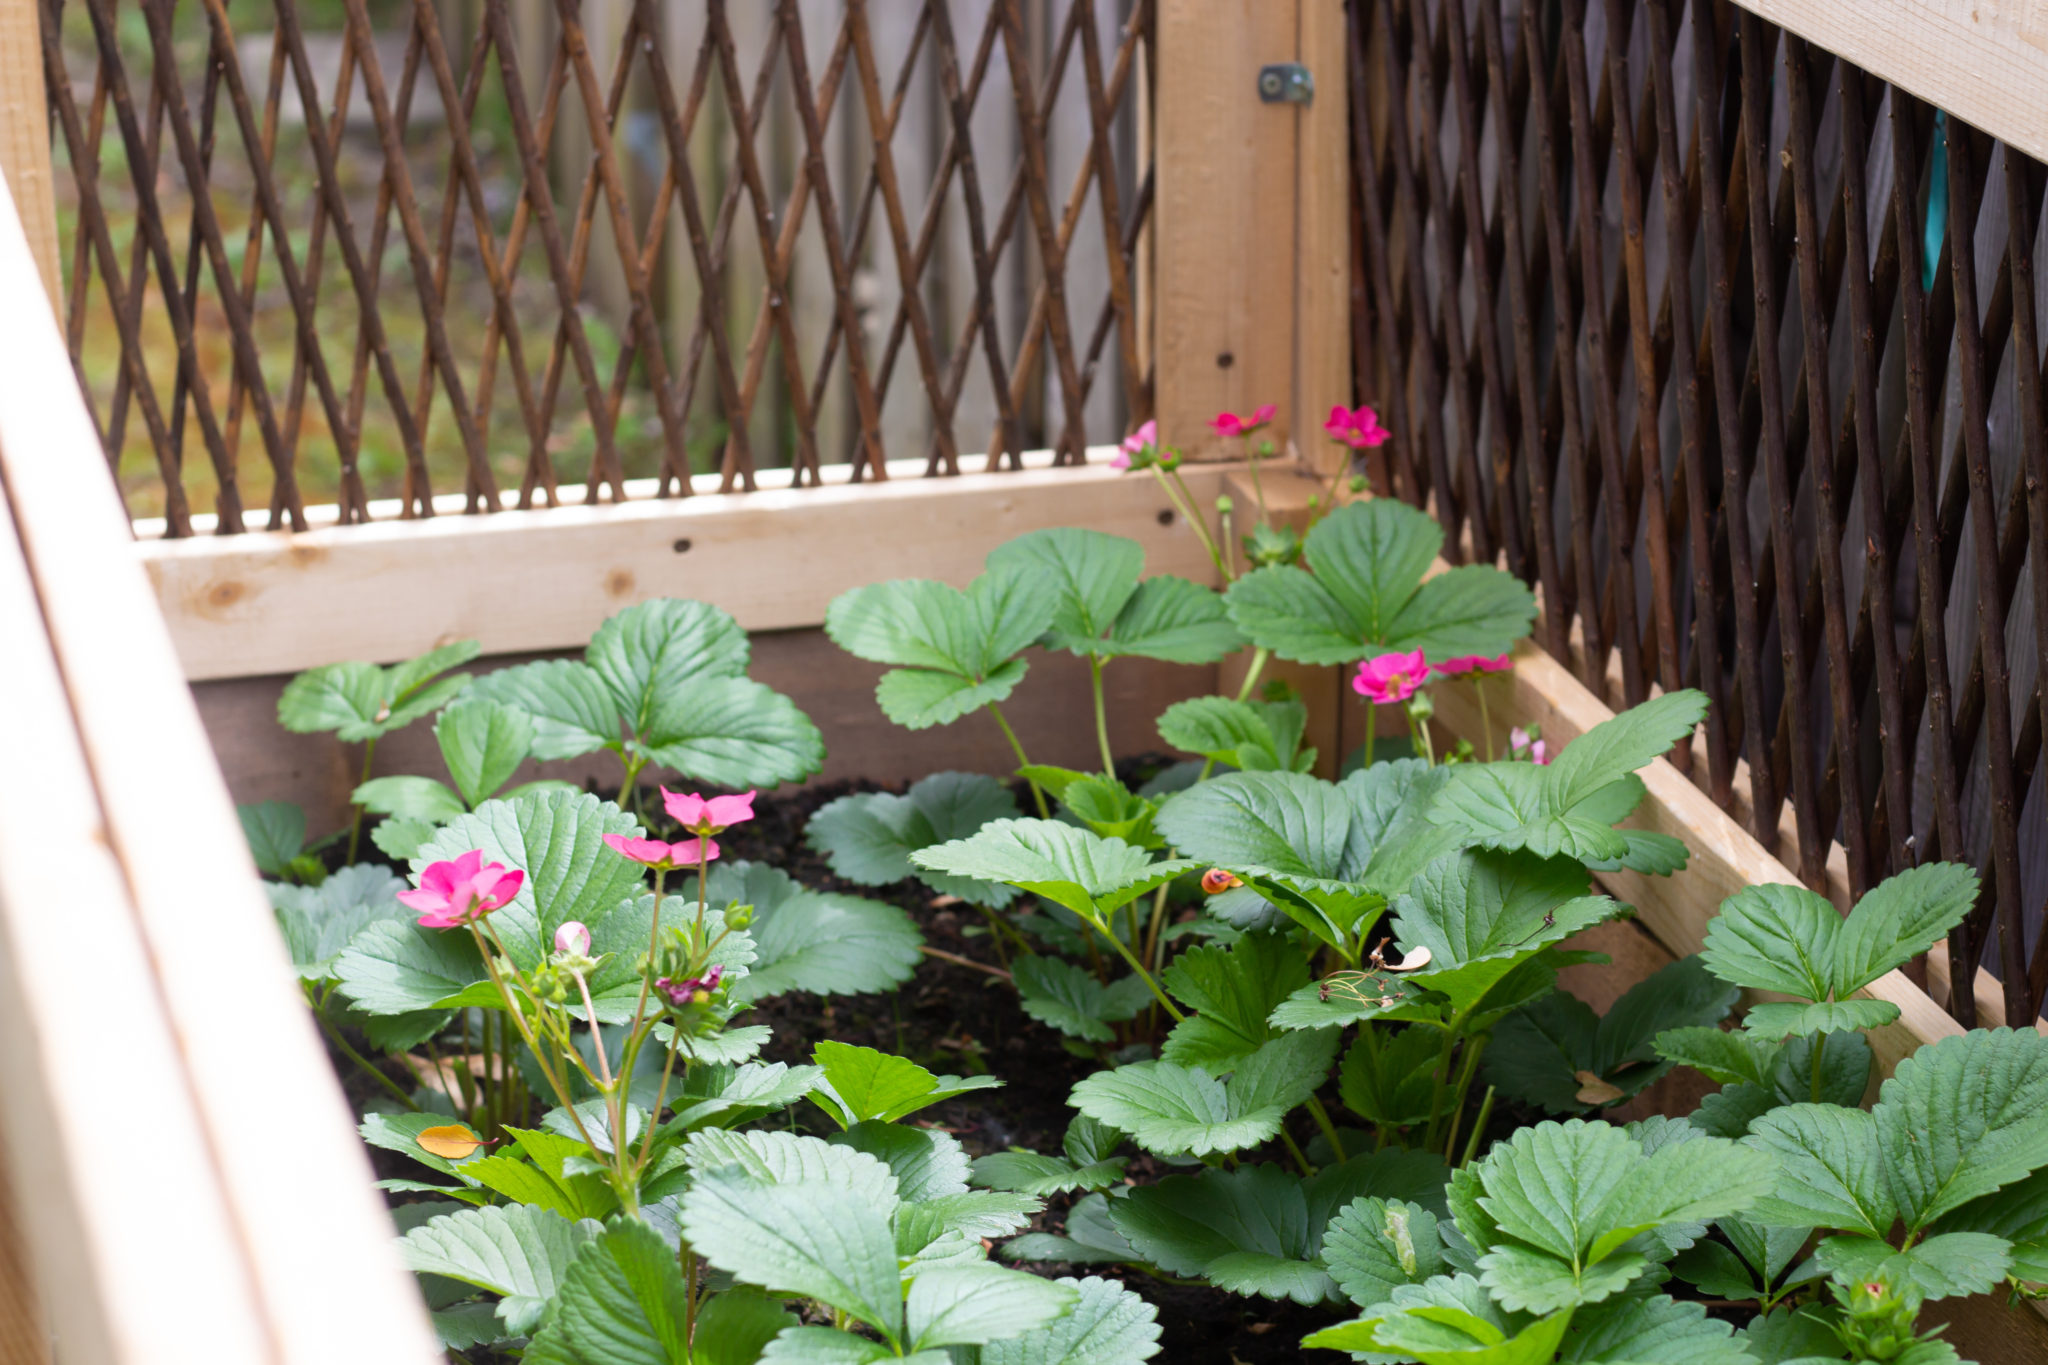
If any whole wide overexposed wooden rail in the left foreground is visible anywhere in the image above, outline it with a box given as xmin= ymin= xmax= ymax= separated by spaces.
xmin=0 ymin=170 xmax=440 ymax=1365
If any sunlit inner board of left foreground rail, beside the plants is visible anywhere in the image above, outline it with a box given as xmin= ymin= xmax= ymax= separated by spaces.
xmin=0 ymin=170 xmax=442 ymax=1365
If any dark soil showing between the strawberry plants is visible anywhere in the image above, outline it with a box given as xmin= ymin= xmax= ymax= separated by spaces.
xmin=336 ymin=773 xmax=1350 ymax=1365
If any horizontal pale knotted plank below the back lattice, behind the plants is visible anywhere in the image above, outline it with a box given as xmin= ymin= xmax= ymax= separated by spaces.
xmin=133 ymin=448 xmax=1229 ymax=681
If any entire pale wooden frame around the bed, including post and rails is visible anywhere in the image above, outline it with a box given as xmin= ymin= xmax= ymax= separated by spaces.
xmin=12 ymin=0 xmax=2048 ymax=1365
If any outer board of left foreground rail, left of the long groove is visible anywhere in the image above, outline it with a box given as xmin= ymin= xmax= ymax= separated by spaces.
xmin=0 ymin=489 xmax=274 ymax=1365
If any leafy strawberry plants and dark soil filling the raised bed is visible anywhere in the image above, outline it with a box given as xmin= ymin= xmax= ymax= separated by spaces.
xmin=228 ymin=462 xmax=2048 ymax=1365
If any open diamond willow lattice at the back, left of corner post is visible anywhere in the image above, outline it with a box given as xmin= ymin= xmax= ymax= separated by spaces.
xmin=43 ymin=0 xmax=1151 ymax=536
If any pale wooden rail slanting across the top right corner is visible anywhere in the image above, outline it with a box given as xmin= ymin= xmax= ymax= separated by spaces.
xmin=1737 ymin=0 xmax=2048 ymax=160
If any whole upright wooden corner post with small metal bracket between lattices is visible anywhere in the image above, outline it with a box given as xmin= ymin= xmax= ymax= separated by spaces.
xmin=1151 ymin=0 xmax=1352 ymax=458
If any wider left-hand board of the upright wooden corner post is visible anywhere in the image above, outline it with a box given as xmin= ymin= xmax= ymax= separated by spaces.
xmin=1151 ymin=0 xmax=1294 ymax=458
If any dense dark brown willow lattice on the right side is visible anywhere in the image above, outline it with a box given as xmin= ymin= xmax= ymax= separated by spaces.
xmin=1350 ymin=0 xmax=2048 ymax=1023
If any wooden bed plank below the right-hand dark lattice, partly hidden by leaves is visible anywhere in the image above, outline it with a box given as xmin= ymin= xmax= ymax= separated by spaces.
xmin=1432 ymin=639 xmax=1962 ymax=1076
